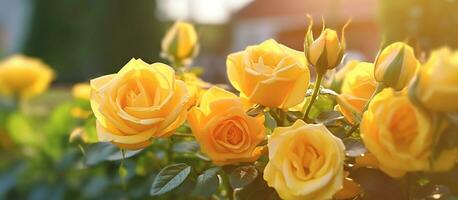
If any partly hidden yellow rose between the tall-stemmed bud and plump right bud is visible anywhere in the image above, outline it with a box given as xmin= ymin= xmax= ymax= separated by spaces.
xmin=337 ymin=62 xmax=377 ymax=123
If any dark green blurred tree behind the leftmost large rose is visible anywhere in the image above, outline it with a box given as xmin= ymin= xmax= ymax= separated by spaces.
xmin=24 ymin=0 xmax=164 ymax=82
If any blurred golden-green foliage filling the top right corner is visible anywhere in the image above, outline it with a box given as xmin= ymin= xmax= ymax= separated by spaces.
xmin=380 ymin=0 xmax=458 ymax=52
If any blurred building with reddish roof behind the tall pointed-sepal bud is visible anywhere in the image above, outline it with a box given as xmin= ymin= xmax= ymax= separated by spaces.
xmin=231 ymin=0 xmax=380 ymax=59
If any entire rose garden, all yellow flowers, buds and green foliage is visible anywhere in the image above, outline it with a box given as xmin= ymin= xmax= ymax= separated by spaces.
xmin=0 ymin=17 xmax=458 ymax=200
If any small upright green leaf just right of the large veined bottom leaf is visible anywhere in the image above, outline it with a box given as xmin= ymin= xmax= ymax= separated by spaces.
xmin=193 ymin=167 xmax=221 ymax=197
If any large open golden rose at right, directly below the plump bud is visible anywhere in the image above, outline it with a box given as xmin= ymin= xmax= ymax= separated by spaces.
xmin=360 ymin=88 xmax=457 ymax=177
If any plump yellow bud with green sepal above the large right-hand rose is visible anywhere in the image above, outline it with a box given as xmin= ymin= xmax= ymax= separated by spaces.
xmin=374 ymin=42 xmax=420 ymax=90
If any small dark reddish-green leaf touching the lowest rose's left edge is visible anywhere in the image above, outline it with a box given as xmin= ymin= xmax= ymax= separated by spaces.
xmin=229 ymin=165 xmax=258 ymax=188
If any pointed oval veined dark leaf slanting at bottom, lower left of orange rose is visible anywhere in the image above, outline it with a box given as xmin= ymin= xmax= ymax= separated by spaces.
xmin=150 ymin=163 xmax=191 ymax=196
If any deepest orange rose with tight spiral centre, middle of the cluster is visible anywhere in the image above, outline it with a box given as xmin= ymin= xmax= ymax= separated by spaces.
xmin=188 ymin=87 xmax=265 ymax=165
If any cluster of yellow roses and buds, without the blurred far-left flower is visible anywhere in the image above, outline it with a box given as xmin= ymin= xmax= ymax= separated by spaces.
xmin=75 ymin=19 xmax=458 ymax=199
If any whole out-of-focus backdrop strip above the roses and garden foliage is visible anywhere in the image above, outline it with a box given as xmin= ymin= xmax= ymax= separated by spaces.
xmin=0 ymin=0 xmax=458 ymax=85
